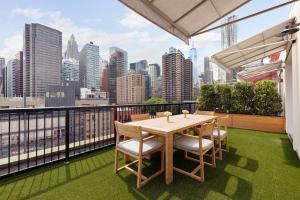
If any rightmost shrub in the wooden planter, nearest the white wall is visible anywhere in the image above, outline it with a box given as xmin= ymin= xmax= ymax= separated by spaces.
xmin=255 ymin=81 xmax=282 ymax=116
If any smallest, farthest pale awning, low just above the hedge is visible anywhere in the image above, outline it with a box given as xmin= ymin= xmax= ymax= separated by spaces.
xmin=237 ymin=61 xmax=282 ymax=81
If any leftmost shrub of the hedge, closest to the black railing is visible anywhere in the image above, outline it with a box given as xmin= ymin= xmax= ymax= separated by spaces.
xmin=198 ymin=85 xmax=216 ymax=110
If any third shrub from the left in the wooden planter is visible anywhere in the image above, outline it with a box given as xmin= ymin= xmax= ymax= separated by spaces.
xmin=231 ymin=83 xmax=255 ymax=114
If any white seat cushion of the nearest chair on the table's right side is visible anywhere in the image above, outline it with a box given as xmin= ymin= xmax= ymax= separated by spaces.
xmin=174 ymin=136 xmax=214 ymax=151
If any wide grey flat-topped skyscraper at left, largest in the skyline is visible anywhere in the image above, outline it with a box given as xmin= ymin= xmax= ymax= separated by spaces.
xmin=23 ymin=23 xmax=62 ymax=97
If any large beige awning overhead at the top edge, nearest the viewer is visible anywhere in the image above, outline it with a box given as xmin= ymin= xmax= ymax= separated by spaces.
xmin=119 ymin=0 xmax=250 ymax=44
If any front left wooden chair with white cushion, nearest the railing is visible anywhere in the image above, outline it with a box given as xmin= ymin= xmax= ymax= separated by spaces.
xmin=114 ymin=121 xmax=164 ymax=188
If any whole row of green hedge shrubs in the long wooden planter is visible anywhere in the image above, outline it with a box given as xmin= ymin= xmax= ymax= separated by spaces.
xmin=198 ymin=81 xmax=282 ymax=116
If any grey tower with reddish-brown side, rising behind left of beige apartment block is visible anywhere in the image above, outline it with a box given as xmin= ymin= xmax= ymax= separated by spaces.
xmin=108 ymin=47 xmax=128 ymax=103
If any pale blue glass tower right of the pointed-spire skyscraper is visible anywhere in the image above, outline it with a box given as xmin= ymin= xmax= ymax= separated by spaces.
xmin=79 ymin=42 xmax=100 ymax=89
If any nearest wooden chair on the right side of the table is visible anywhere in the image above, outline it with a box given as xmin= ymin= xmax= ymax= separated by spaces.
xmin=174 ymin=122 xmax=216 ymax=182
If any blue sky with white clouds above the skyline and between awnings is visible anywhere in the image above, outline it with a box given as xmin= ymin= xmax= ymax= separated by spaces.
xmin=0 ymin=0 xmax=290 ymax=76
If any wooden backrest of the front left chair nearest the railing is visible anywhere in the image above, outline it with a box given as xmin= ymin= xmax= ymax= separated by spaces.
xmin=115 ymin=121 xmax=142 ymax=139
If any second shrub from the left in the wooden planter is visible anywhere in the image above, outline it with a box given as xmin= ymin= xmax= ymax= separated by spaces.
xmin=215 ymin=84 xmax=231 ymax=113
